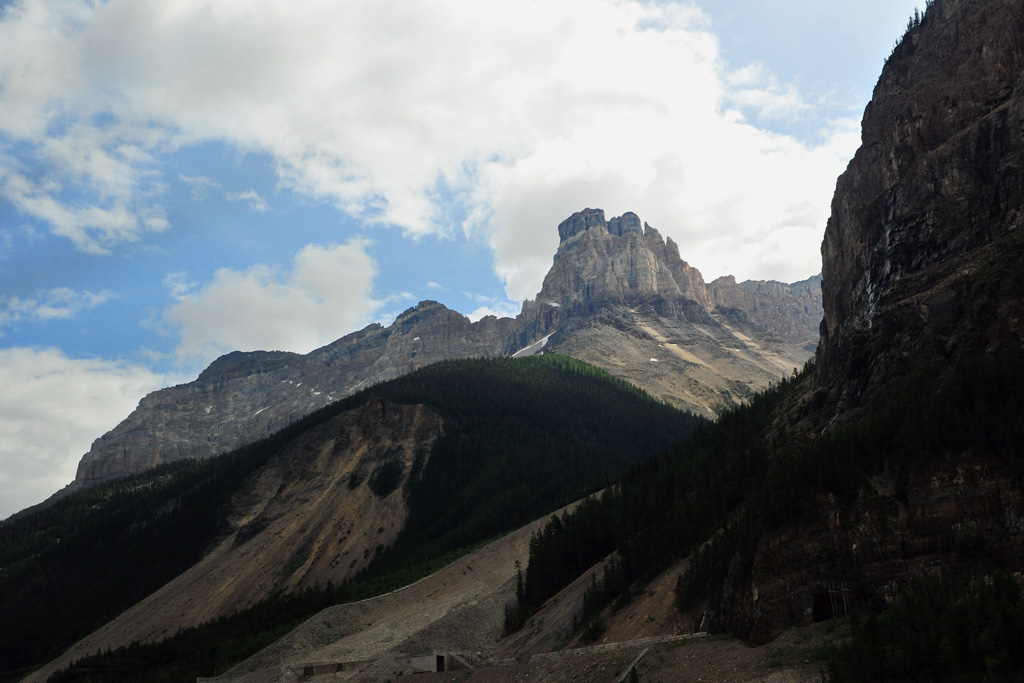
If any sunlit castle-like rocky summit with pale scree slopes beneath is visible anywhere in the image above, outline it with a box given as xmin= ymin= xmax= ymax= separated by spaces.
xmin=509 ymin=209 xmax=820 ymax=417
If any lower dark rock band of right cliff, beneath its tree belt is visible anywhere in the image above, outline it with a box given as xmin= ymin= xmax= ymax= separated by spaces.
xmin=724 ymin=454 xmax=1024 ymax=642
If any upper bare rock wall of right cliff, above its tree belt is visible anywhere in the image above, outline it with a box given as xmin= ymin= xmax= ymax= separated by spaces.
xmin=818 ymin=0 xmax=1024 ymax=404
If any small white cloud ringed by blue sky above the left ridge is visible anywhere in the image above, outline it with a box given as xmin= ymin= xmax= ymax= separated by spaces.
xmin=165 ymin=239 xmax=381 ymax=361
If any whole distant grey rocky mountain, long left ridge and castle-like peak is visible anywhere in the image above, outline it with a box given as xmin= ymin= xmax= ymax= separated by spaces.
xmin=74 ymin=209 xmax=820 ymax=490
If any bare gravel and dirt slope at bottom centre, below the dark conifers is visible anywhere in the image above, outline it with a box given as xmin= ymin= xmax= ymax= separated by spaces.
xmin=216 ymin=501 xmax=823 ymax=683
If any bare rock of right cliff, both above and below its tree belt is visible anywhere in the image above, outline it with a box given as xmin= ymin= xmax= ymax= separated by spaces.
xmin=722 ymin=0 xmax=1024 ymax=641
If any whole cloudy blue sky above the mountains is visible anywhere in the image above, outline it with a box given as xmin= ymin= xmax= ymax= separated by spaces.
xmin=0 ymin=0 xmax=924 ymax=518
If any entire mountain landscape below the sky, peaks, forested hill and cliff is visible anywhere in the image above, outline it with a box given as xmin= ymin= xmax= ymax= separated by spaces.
xmin=0 ymin=0 xmax=1024 ymax=682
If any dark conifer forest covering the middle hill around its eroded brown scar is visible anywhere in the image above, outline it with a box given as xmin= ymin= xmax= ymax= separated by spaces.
xmin=0 ymin=355 xmax=705 ymax=680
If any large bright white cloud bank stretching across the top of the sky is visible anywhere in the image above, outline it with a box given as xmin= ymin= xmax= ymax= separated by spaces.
xmin=0 ymin=0 xmax=856 ymax=286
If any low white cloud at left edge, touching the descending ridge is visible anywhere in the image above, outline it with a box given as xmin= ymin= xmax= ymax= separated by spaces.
xmin=0 ymin=348 xmax=168 ymax=518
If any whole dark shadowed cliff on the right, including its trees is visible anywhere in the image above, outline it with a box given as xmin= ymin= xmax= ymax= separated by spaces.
xmin=717 ymin=0 xmax=1024 ymax=642
